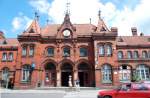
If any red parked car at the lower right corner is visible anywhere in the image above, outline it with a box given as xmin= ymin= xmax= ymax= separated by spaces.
xmin=98 ymin=83 xmax=150 ymax=98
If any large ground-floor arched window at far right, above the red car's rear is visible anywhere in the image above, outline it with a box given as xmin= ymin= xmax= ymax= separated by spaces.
xmin=136 ymin=64 xmax=150 ymax=80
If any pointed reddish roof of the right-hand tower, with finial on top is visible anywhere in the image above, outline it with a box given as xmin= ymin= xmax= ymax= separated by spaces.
xmin=96 ymin=11 xmax=109 ymax=33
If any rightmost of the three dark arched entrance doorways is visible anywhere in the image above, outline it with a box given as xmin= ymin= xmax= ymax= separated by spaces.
xmin=78 ymin=63 xmax=92 ymax=87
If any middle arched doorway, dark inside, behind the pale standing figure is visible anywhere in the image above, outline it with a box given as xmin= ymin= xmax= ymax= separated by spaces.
xmin=61 ymin=63 xmax=73 ymax=86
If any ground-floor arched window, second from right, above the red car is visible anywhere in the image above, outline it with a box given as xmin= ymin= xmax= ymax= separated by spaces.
xmin=119 ymin=65 xmax=131 ymax=82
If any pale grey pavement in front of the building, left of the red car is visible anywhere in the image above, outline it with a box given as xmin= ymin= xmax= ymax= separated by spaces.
xmin=0 ymin=89 xmax=99 ymax=98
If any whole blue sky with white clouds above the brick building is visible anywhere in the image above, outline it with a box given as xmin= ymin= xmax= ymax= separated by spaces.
xmin=0 ymin=0 xmax=150 ymax=38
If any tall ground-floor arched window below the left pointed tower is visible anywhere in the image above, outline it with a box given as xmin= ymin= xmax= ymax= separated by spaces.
xmin=22 ymin=65 xmax=31 ymax=82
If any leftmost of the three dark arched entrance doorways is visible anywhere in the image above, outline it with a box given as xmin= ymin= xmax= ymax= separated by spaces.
xmin=45 ymin=62 xmax=56 ymax=86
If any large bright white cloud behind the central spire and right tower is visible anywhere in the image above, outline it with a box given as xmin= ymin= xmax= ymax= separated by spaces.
xmin=30 ymin=0 xmax=150 ymax=35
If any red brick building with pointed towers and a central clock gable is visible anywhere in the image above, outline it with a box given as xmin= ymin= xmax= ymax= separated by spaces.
xmin=0 ymin=14 xmax=150 ymax=88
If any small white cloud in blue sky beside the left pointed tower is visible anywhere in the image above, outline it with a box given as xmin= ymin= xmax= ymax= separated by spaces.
xmin=12 ymin=13 xmax=32 ymax=32
